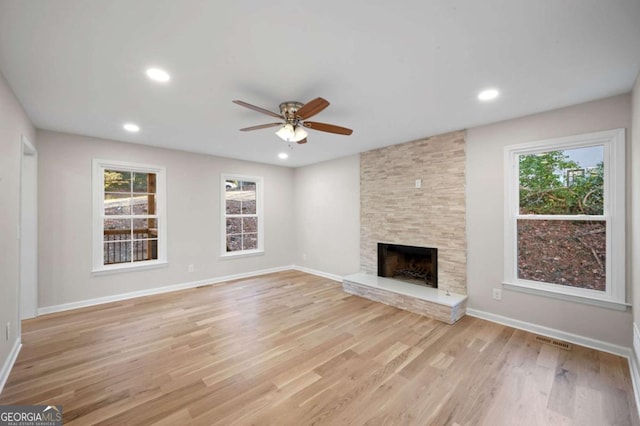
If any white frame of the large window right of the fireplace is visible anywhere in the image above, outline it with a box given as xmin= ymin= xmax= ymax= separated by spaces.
xmin=503 ymin=129 xmax=628 ymax=310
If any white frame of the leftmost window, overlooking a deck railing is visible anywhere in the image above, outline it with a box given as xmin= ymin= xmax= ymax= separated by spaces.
xmin=92 ymin=159 xmax=167 ymax=274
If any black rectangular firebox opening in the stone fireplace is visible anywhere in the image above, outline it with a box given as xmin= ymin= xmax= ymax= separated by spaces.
xmin=378 ymin=243 xmax=438 ymax=288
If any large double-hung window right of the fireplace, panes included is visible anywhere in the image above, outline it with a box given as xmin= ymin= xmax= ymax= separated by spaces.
xmin=504 ymin=129 xmax=625 ymax=309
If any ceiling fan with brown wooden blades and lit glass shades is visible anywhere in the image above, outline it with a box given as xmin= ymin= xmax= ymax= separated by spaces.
xmin=233 ymin=98 xmax=353 ymax=144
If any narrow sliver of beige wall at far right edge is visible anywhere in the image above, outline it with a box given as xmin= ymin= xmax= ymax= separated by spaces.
xmin=628 ymin=74 xmax=640 ymax=340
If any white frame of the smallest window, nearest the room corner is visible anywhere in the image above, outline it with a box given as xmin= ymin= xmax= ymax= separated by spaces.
xmin=220 ymin=173 xmax=264 ymax=259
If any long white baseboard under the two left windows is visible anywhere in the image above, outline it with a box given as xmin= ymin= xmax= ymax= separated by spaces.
xmin=38 ymin=266 xmax=294 ymax=315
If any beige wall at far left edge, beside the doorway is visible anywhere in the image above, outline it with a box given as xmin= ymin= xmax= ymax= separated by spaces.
xmin=0 ymin=75 xmax=36 ymax=372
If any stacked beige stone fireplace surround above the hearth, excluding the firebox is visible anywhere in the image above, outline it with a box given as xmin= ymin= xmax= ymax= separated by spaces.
xmin=360 ymin=131 xmax=467 ymax=294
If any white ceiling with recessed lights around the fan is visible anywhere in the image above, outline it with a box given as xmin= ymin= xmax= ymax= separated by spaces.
xmin=0 ymin=0 xmax=640 ymax=167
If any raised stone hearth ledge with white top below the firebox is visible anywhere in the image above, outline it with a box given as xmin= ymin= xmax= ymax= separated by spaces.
xmin=342 ymin=272 xmax=467 ymax=324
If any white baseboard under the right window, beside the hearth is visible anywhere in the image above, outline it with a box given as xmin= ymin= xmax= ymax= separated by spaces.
xmin=467 ymin=308 xmax=632 ymax=359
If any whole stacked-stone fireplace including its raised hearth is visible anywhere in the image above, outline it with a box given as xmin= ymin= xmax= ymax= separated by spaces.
xmin=343 ymin=131 xmax=467 ymax=324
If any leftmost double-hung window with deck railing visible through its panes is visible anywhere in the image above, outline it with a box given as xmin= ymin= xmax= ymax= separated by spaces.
xmin=93 ymin=160 xmax=166 ymax=272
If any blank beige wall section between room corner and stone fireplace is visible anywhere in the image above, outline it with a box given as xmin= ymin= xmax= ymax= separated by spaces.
xmin=294 ymin=155 xmax=360 ymax=275
